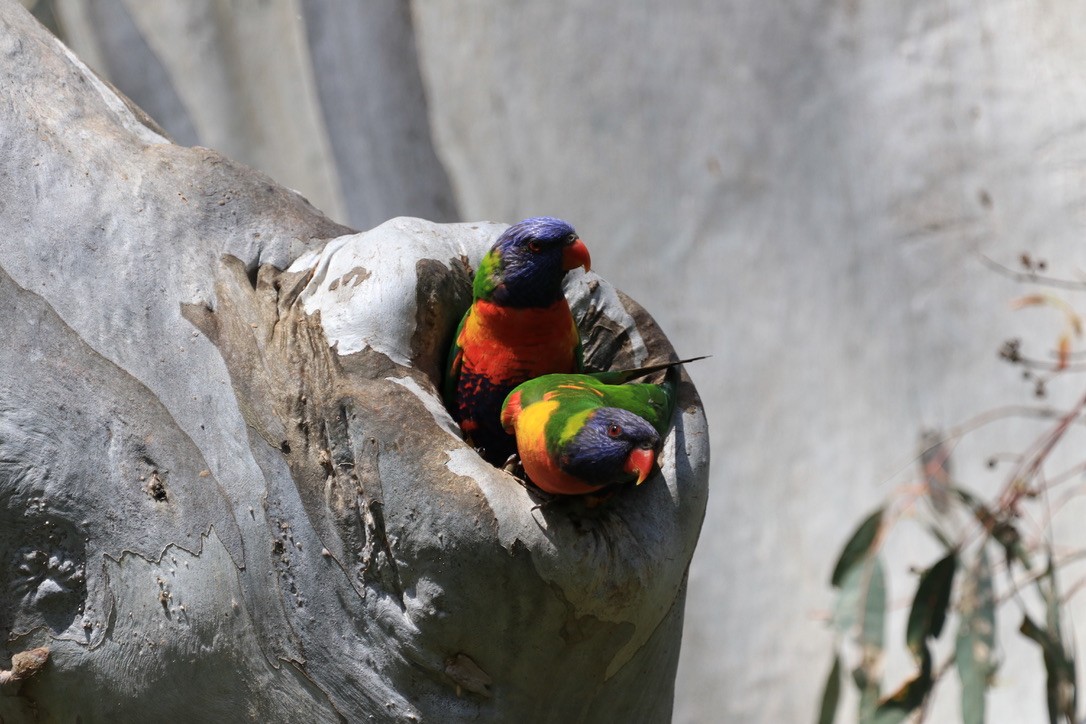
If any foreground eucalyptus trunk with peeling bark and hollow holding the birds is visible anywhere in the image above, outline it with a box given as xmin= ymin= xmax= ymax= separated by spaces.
xmin=0 ymin=2 xmax=708 ymax=722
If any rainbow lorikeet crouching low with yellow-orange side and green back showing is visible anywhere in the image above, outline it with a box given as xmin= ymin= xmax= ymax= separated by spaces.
xmin=502 ymin=357 xmax=702 ymax=495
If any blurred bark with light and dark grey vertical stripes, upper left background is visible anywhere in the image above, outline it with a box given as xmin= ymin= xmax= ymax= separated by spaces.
xmin=58 ymin=0 xmax=457 ymax=228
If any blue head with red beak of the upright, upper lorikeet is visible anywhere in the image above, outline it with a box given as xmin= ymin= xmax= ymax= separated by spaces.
xmin=475 ymin=216 xmax=592 ymax=307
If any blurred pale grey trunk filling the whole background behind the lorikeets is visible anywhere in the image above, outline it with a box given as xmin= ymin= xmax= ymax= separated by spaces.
xmin=24 ymin=0 xmax=1086 ymax=722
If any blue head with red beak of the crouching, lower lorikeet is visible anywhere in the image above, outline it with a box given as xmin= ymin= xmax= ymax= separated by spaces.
xmin=560 ymin=407 xmax=660 ymax=486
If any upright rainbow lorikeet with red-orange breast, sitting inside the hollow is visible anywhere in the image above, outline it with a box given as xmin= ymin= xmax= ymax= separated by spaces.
xmin=444 ymin=216 xmax=592 ymax=465
